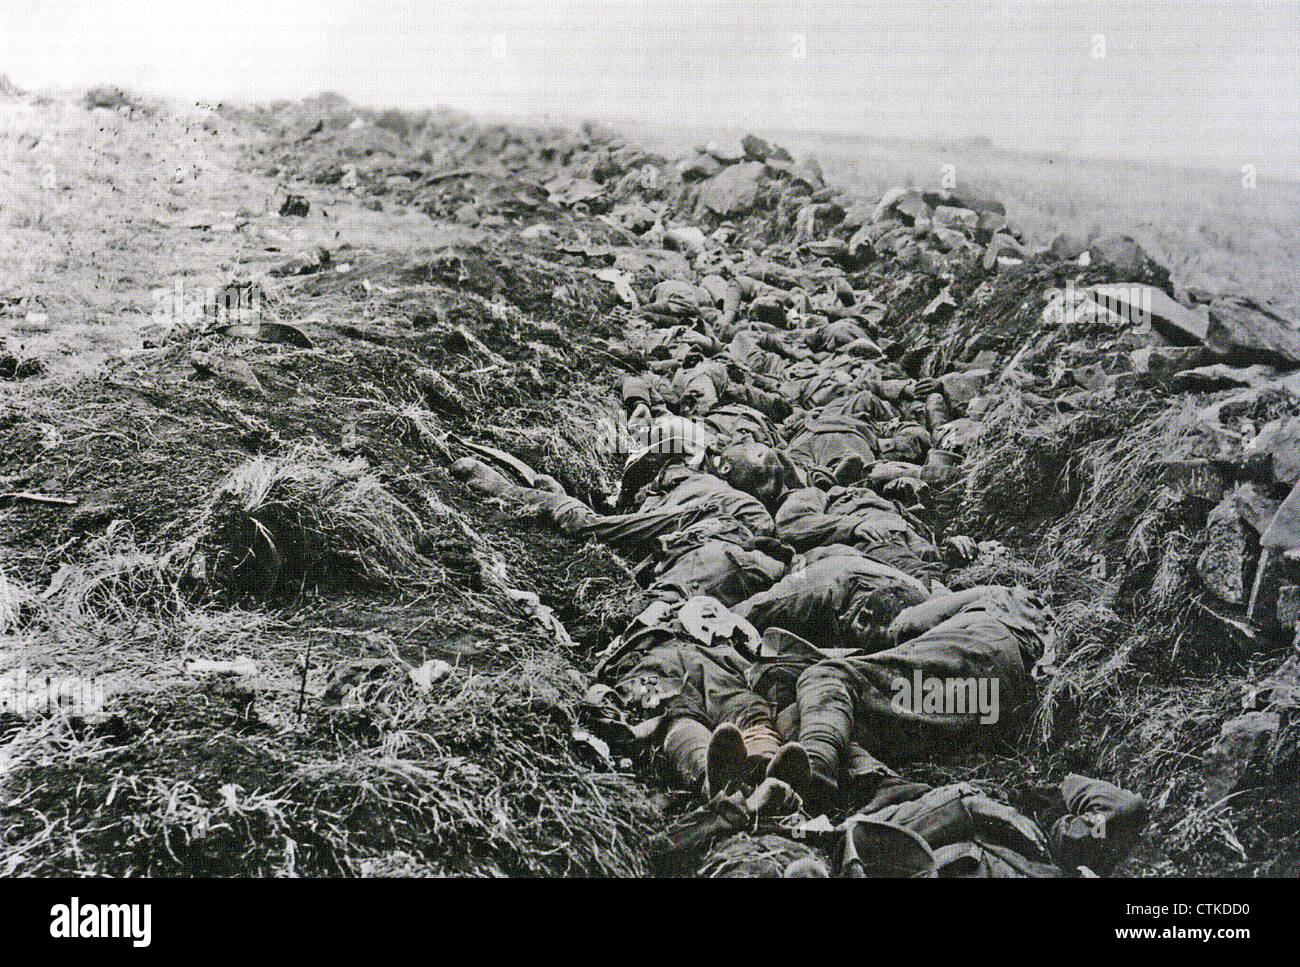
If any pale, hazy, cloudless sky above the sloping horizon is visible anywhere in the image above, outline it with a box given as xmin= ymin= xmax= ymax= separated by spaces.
xmin=0 ymin=0 xmax=1300 ymax=172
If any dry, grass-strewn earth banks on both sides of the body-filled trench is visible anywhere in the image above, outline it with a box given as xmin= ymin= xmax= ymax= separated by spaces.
xmin=0 ymin=87 xmax=1300 ymax=876
